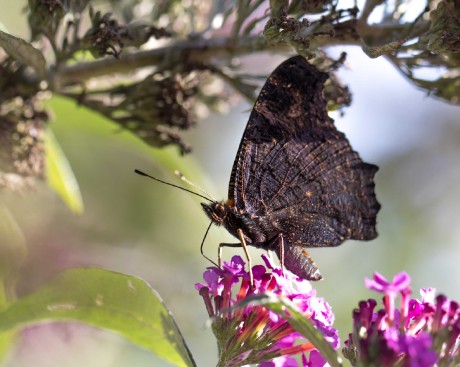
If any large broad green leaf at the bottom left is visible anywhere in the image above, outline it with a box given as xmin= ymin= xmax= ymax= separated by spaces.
xmin=0 ymin=269 xmax=195 ymax=367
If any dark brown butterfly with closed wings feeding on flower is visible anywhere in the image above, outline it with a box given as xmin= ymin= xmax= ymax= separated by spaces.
xmin=201 ymin=56 xmax=380 ymax=280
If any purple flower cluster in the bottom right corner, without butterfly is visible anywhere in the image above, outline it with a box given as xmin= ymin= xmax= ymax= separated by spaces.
xmin=343 ymin=272 xmax=460 ymax=367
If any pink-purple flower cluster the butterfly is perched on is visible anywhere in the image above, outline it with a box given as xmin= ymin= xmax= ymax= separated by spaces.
xmin=195 ymin=255 xmax=339 ymax=367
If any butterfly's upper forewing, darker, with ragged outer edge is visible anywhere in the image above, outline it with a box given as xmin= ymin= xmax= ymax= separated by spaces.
xmin=228 ymin=56 xmax=334 ymax=205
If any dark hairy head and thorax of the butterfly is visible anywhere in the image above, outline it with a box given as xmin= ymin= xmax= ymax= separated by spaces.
xmin=201 ymin=200 xmax=267 ymax=246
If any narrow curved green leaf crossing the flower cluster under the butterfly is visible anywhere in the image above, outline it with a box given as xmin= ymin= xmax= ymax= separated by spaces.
xmin=237 ymin=294 xmax=342 ymax=367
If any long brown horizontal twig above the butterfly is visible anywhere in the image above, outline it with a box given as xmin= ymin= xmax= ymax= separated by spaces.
xmin=35 ymin=22 xmax=430 ymax=91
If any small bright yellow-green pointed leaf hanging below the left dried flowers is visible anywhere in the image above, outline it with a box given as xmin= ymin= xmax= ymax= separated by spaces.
xmin=45 ymin=128 xmax=83 ymax=214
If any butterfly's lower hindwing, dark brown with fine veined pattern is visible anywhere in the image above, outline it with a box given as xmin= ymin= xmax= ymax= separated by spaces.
xmin=258 ymin=137 xmax=380 ymax=243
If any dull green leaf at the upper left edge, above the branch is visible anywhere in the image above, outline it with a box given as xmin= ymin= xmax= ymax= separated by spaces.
xmin=0 ymin=31 xmax=46 ymax=78
